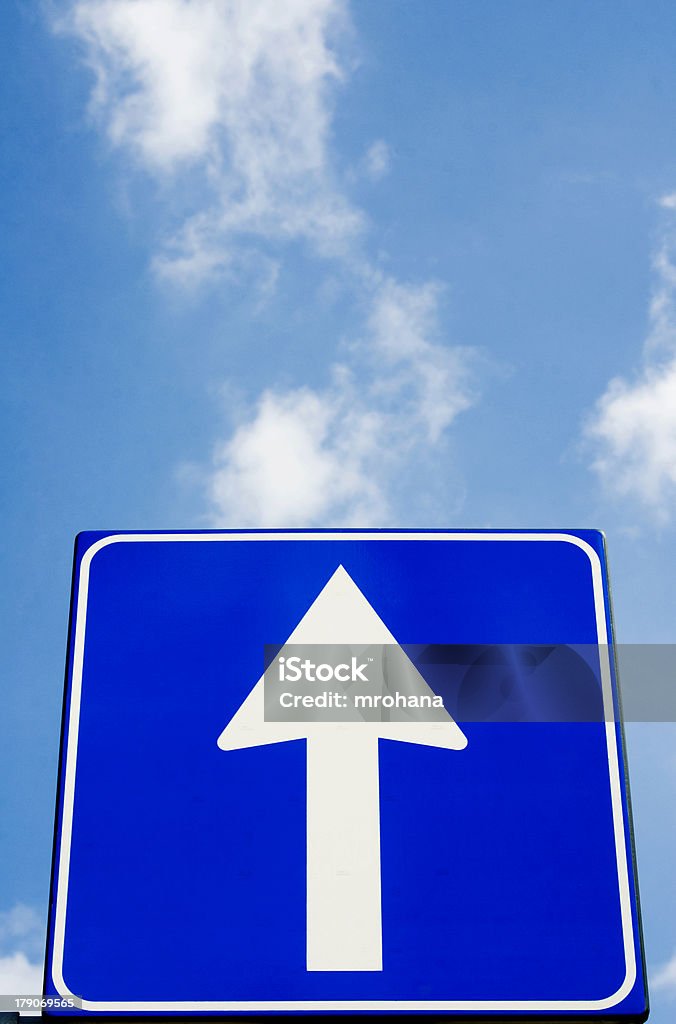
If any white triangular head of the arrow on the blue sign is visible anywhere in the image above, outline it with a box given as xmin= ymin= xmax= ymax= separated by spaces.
xmin=218 ymin=565 xmax=467 ymax=751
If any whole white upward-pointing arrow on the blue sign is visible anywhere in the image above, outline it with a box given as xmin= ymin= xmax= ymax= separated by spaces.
xmin=218 ymin=565 xmax=467 ymax=971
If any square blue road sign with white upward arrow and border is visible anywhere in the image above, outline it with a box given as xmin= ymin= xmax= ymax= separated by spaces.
xmin=46 ymin=530 xmax=646 ymax=1021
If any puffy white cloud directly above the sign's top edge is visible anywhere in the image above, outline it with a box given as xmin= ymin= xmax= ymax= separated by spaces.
xmin=207 ymin=279 xmax=473 ymax=526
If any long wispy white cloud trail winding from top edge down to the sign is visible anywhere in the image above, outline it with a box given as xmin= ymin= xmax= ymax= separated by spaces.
xmin=59 ymin=0 xmax=475 ymax=526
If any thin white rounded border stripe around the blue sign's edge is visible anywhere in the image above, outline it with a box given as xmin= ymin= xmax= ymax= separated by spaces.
xmin=52 ymin=531 xmax=636 ymax=1013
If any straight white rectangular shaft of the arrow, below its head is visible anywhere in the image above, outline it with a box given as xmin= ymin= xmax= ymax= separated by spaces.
xmin=307 ymin=726 xmax=383 ymax=971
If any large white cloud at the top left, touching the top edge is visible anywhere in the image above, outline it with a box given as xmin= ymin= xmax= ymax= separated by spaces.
xmin=57 ymin=0 xmax=363 ymax=284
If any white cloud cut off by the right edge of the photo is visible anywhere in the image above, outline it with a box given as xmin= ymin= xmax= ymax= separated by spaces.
xmin=585 ymin=216 xmax=676 ymax=522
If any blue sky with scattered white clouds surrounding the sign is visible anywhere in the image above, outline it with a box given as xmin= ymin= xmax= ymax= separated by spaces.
xmin=0 ymin=0 xmax=676 ymax=1022
